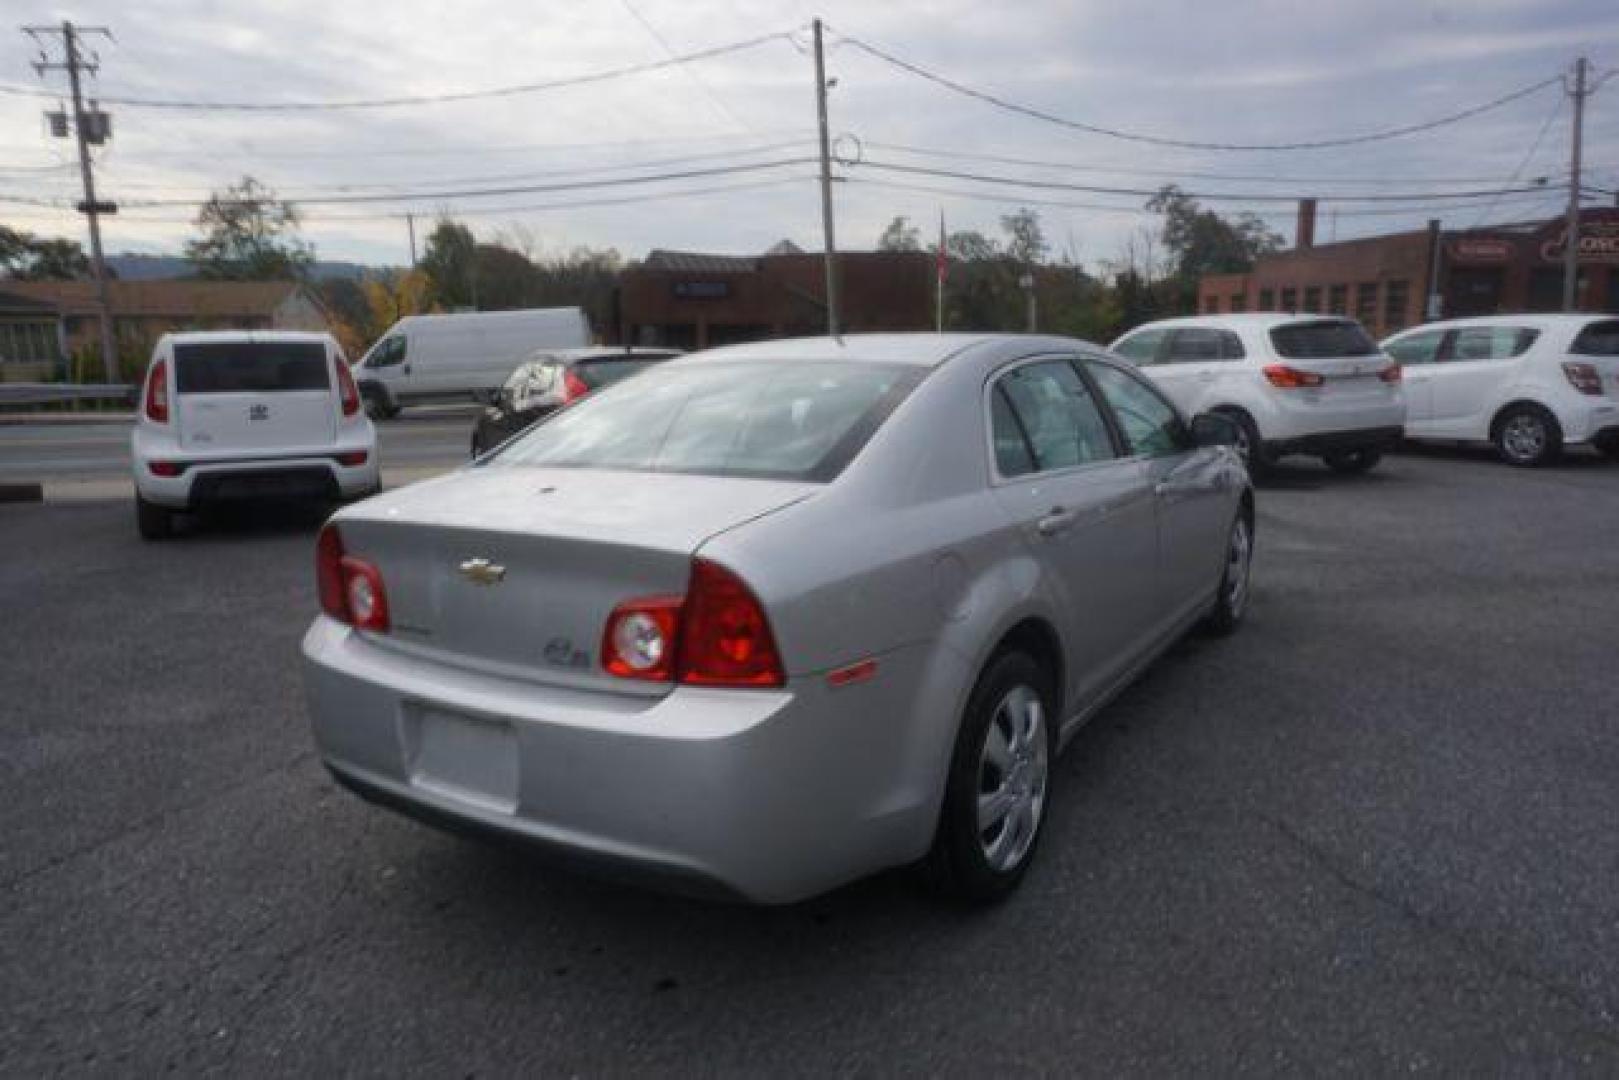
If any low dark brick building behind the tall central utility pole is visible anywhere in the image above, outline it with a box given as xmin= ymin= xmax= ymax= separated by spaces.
xmin=617 ymin=241 xmax=934 ymax=350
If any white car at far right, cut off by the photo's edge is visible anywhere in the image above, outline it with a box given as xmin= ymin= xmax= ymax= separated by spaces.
xmin=1383 ymin=316 xmax=1619 ymax=465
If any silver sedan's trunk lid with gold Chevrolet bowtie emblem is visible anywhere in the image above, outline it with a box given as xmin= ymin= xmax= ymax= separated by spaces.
xmin=338 ymin=466 xmax=818 ymax=695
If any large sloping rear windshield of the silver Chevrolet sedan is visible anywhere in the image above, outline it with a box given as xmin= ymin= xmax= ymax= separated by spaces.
xmin=486 ymin=361 xmax=921 ymax=483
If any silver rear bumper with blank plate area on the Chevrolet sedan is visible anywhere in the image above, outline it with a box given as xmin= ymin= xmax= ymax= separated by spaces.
xmin=303 ymin=617 xmax=937 ymax=904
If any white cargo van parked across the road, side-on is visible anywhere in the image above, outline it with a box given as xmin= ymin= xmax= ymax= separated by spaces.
xmin=355 ymin=308 xmax=591 ymax=416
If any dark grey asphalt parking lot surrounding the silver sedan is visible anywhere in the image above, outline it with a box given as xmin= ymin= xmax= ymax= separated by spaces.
xmin=0 ymin=452 xmax=1619 ymax=1075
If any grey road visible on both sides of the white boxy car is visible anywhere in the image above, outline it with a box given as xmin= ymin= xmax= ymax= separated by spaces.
xmin=0 ymin=406 xmax=476 ymax=483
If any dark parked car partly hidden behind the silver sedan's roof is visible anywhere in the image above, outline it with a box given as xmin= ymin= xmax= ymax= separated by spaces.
xmin=473 ymin=347 xmax=680 ymax=457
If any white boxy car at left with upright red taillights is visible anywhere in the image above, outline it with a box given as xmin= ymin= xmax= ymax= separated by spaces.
xmin=130 ymin=330 xmax=380 ymax=539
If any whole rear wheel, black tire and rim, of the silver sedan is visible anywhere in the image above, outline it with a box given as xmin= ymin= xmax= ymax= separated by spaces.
xmin=924 ymin=653 xmax=1057 ymax=904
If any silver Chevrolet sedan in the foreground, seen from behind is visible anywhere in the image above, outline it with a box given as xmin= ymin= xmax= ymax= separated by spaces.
xmin=303 ymin=334 xmax=1253 ymax=902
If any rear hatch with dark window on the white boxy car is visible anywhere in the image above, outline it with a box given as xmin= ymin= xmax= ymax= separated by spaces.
xmin=175 ymin=338 xmax=338 ymax=452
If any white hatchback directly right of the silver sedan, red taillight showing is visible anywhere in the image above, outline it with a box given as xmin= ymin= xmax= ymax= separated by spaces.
xmin=1112 ymin=313 xmax=1405 ymax=473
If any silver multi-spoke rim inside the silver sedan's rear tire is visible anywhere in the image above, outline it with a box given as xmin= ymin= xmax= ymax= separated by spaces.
xmin=978 ymin=683 xmax=1051 ymax=873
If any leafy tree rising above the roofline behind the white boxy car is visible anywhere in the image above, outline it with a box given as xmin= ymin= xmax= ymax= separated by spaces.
xmin=186 ymin=176 xmax=314 ymax=282
